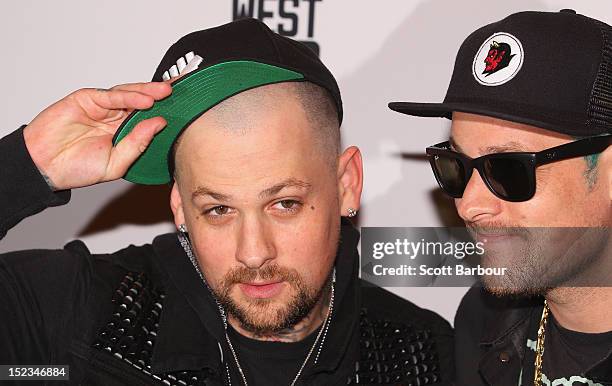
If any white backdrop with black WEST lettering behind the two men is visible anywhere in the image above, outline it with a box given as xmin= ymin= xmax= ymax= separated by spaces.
xmin=0 ymin=0 xmax=612 ymax=322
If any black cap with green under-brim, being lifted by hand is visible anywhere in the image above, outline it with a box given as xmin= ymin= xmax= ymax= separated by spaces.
xmin=113 ymin=19 xmax=342 ymax=185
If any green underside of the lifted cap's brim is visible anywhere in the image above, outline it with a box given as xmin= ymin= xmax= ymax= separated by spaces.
xmin=113 ymin=60 xmax=304 ymax=185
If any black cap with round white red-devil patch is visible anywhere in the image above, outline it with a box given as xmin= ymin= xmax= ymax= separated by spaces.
xmin=389 ymin=10 xmax=612 ymax=136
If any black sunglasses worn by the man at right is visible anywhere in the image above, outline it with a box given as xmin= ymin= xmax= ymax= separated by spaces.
xmin=426 ymin=134 xmax=612 ymax=202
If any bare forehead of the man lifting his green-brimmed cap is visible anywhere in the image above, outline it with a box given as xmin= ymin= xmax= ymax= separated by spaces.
xmin=176 ymin=91 xmax=323 ymax=190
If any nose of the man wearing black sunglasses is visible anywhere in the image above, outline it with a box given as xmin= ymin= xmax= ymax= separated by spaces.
xmin=455 ymin=170 xmax=502 ymax=222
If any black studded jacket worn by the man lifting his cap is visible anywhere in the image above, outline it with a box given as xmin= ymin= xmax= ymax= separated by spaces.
xmin=0 ymin=130 xmax=454 ymax=386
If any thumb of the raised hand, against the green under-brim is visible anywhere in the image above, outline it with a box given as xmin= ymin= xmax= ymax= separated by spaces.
xmin=106 ymin=117 xmax=166 ymax=181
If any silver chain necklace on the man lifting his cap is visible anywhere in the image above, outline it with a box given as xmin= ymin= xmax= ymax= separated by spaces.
xmin=178 ymin=232 xmax=336 ymax=386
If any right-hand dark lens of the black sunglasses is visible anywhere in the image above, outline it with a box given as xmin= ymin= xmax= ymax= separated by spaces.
xmin=484 ymin=158 xmax=532 ymax=201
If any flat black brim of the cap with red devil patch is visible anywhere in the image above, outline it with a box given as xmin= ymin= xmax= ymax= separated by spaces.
xmin=388 ymin=102 xmax=606 ymax=136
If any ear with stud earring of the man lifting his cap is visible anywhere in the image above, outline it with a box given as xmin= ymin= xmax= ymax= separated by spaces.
xmin=337 ymin=146 xmax=363 ymax=216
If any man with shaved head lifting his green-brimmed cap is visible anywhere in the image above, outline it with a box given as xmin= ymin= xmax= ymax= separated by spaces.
xmin=0 ymin=19 xmax=453 ymax=386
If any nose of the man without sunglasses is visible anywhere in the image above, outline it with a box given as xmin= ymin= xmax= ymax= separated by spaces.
xmin=236 ymin=215 xmax=276 ymax=269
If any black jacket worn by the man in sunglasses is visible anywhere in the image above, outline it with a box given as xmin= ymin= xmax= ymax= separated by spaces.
xmin=455 ymin=287 xmax=612 ymax=386
